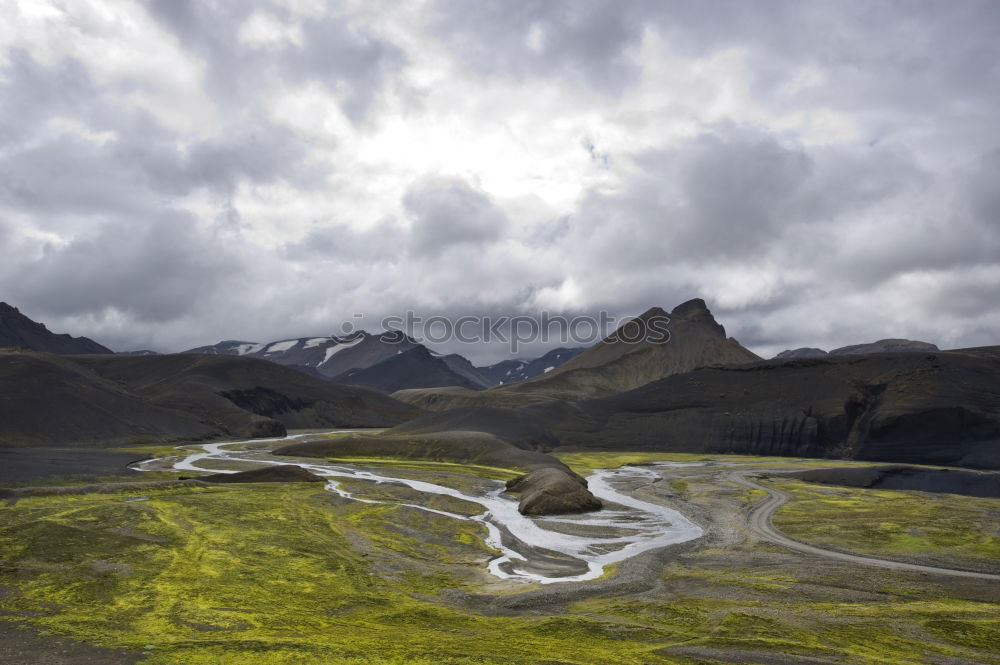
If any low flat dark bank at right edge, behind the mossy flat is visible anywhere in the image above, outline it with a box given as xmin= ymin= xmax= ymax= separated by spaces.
xmin=783 ymin=465 xmax=1000 ymax=498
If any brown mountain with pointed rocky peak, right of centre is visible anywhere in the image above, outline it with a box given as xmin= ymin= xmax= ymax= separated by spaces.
xmin=393 ymin=298 xmax=760 ymax=411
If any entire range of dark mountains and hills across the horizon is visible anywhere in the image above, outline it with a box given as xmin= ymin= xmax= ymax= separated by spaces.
xmin=0 ymin=299 xmax=1000 ymax=480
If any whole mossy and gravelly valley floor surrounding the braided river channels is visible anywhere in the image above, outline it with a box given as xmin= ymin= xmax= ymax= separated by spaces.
xmin=0 ymin=440 xmax=1000 ymax=665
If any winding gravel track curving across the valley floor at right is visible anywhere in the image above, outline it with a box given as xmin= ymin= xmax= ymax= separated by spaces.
xmin=729 ymin=471 xmax=1000 ymax=582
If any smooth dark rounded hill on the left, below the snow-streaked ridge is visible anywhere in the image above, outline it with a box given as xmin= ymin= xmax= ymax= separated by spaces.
xmin=0 ymin=351 xmax=419 ymax=447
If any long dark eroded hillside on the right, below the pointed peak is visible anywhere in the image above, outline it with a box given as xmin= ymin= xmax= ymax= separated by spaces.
xmin=375 ymin=347 xmax=1000 ymax=469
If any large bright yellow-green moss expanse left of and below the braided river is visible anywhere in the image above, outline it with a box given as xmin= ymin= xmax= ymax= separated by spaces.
xmin=0 ymin=484 xmax=684 ymax=665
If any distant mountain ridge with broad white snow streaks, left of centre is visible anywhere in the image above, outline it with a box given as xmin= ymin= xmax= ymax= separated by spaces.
xmin=184 ymin=330 xmax=417 ymax=379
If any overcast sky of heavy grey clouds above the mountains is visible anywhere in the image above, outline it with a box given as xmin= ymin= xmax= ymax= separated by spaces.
xmin=0 ymin=0 xmax=1000 ymax=362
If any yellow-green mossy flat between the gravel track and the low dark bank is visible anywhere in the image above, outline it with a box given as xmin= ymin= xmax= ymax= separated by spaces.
xmin=769 ymin=478 xmax=1000 ymax=570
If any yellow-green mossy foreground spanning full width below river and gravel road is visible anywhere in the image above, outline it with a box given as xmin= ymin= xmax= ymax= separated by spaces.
xmin=0 ymin=458 xmax=1000 ymax=665
